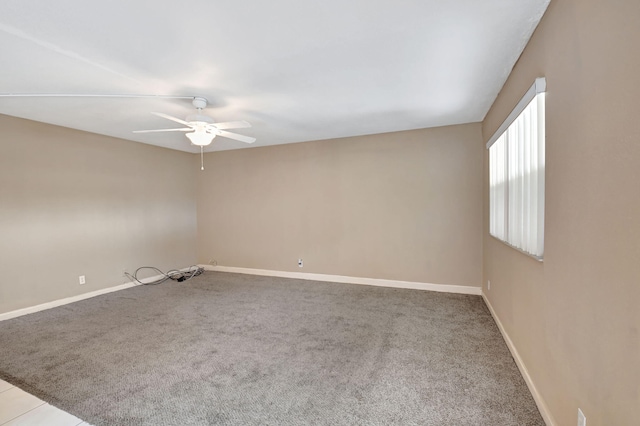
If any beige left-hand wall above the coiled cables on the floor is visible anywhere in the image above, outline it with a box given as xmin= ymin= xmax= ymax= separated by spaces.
xmin=0 ymin=115 xmax=198 ymax=313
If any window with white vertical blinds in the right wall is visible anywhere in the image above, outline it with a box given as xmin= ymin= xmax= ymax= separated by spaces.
xmin=487 ymin=78 xmax=546 ymax=260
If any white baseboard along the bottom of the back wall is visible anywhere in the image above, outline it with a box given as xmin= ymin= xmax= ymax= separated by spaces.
xmin=198 ymin=265 xmax=482 ymax=296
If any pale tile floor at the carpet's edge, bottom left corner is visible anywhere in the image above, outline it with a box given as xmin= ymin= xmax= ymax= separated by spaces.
xmin=0 ymin=380 xmax=91 ymax=426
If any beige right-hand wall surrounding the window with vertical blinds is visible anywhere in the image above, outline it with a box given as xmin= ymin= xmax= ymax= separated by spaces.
xmin=483 ymin=0 xmax=640 ymax=426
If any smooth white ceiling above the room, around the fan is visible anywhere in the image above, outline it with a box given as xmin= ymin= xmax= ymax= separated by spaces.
xmin=0 ymin=0 xmax=549 ymax=152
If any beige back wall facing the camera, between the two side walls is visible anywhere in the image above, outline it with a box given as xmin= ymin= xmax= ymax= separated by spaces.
xmin=198 ymin=124 xmax=483 ymax=287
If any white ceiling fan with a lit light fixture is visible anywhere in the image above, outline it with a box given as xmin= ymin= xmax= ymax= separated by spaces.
xmin=133 ymin=97 xmax=256 ymax=149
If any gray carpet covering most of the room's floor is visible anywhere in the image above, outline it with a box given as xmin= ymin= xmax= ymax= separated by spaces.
xmin=0 ymin=272 xmax=544 ymax=426
